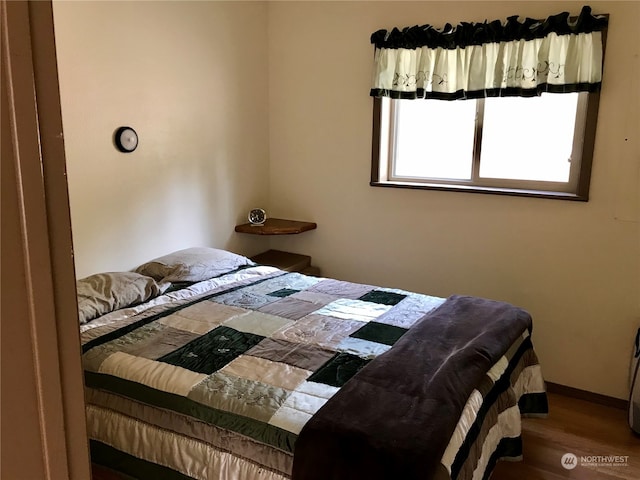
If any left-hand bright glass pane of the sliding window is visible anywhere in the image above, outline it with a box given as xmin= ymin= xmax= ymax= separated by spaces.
xmin=393 ymin=100 xmax=476 ymax=180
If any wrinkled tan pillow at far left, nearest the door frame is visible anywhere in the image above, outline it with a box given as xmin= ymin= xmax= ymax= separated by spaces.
xmin=76 ymin=272 xmax=164 ymax=324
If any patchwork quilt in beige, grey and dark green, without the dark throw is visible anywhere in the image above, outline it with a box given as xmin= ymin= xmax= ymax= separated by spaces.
xmin=81 ymin=267 xmax=546 ymax=479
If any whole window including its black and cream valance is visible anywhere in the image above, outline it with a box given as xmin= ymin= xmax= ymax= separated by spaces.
xmin=369 ymin=6 xmax=609 ymax=201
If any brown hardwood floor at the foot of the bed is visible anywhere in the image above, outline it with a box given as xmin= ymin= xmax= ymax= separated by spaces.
xmin=93 ymin=393 xmax=640 ymax=480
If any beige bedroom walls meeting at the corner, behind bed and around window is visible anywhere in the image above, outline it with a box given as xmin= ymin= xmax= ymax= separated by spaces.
xmin=54 ymin=1 xmax=640 ymax=398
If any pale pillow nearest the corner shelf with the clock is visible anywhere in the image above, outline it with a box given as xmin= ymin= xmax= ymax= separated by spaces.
xmin=136 ymin=247 xmax=255 ymax=282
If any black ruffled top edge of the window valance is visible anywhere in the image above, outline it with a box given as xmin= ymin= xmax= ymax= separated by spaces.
xmin=371 ymin=6 xmax=608 ymax=49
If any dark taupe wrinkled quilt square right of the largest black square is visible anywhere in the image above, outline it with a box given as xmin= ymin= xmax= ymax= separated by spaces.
xmin=246 ymin=338 xmax=335 ymax=372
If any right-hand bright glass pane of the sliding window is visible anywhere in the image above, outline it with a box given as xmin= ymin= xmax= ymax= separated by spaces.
xmin=480 ymin=93 xmax=578 ymax=182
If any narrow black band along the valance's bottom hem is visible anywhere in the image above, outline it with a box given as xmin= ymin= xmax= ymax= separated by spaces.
xmin=370 ymin=83 xmax=601 ymax=100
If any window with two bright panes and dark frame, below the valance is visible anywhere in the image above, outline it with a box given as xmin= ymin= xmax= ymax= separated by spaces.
xmin=371 ymin=92 xmax=599 ymax=201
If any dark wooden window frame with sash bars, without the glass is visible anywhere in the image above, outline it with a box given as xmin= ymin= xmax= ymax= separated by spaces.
xmin=370 ymin=92 xmax=600 ymax=202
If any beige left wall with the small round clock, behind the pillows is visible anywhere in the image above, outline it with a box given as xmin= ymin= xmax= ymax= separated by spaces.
xmin=54 ymin=1 xmax=269 ymax=277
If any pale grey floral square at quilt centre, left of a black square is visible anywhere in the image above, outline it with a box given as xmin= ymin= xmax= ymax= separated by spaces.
xmin=272 ymin=314 xmax=362 ymax=350
